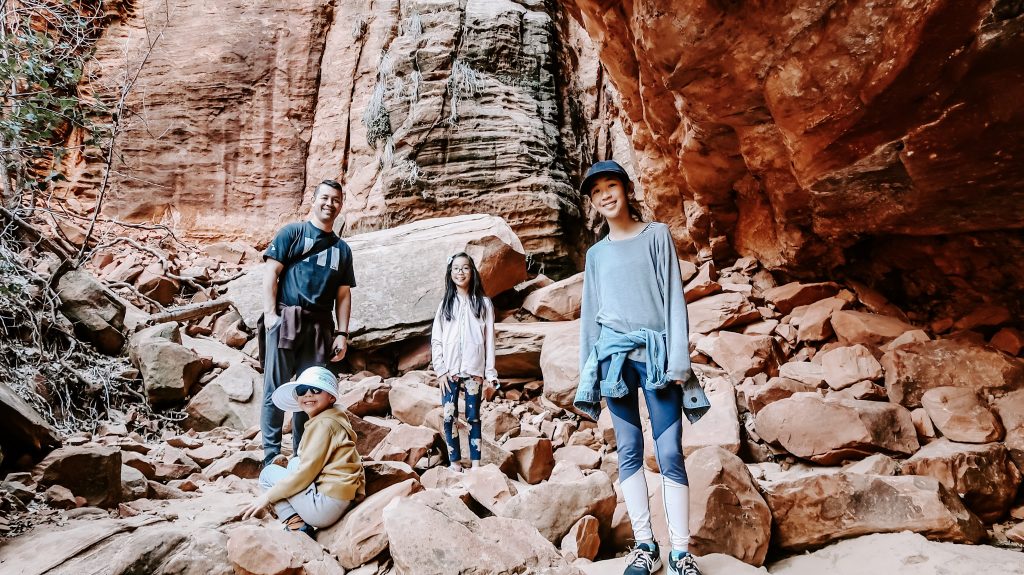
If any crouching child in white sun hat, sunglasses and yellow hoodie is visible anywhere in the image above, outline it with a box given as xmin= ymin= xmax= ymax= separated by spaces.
xmin=242 ymin=366 xmax=366 ymax=537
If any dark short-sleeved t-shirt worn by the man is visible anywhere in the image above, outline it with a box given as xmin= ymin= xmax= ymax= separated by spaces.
xmin=263 ymin=221 xmax=355 ymax=313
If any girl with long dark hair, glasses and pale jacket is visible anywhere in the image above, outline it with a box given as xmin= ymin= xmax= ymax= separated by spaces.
xmin=430 ymin=253 xmax=498 ymax=471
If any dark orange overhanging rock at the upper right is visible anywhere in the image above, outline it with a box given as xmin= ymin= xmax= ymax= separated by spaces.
xmin=573 ymin=0 xmax=1024 ymax=319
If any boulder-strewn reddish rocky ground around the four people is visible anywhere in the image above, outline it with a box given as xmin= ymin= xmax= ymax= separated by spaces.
xmin=0 ymin=216 xmax=1024 ymax=575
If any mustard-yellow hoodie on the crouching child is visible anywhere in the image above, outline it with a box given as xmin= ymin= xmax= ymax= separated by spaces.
xmin=266 ymin=407 xmax=366 ymax=503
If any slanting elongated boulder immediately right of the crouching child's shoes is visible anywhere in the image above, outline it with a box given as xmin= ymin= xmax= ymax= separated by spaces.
xmin=316 ymin=479 xmax=423 ymax=569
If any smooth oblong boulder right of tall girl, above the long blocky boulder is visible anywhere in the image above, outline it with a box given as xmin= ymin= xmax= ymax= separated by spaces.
xmin=755 ymin=393 xmax=920 ymax=466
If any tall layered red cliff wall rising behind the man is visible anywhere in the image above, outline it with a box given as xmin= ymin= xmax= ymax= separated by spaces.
xmin=67 ymin=0 xmax=630 ymax=269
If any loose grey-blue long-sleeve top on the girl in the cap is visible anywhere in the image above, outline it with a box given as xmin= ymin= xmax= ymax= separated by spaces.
xmin=580 ymin=222 xmax=690 ymax=381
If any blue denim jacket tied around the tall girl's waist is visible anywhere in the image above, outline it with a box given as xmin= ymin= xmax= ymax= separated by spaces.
xmin=572 ymin=325 xmax=669 ymax=421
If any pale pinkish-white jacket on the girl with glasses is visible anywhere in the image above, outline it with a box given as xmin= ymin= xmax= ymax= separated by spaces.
xmin=430 ymin=297 xmax=498 ymax=382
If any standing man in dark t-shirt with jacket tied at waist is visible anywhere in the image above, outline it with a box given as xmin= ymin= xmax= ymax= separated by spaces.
xmin=260 ymin=180 xmax=355 ymax=467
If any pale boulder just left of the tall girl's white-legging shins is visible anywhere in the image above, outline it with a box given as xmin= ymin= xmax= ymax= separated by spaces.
xmin=501 ymin=471 xmax=615 ymax=543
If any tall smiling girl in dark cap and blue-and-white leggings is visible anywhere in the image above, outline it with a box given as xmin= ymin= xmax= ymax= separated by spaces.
xmin=574 ymin=162 xmax=700 ymax=575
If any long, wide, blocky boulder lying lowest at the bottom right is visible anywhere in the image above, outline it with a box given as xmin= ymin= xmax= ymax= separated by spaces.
xmin=761 ymin=473 xmax=985 ymax=550
